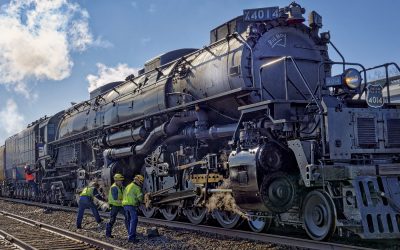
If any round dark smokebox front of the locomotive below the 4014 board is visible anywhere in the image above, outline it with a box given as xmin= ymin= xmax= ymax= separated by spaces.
xmin=250 ymin=23 xmax=327 ymax=100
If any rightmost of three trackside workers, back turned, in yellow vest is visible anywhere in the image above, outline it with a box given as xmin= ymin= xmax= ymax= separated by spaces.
xmin=122 ymin=175 xmax=144 ymax=243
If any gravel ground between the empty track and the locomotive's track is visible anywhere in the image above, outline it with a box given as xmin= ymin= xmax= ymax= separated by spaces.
xmin=0 ymin=201 xmax=290 ymax=250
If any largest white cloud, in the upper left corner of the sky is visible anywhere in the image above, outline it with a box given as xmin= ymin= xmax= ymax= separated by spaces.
xmin=0 ymin=0 xmax=98 ymax=98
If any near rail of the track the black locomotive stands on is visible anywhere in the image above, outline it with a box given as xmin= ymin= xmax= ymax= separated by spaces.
xmin=0 ymin=197 xmax=382 ymax=250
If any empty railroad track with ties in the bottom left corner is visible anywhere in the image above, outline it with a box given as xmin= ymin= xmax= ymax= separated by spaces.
xmin=0 ymin=208 xmax=122 ymax=250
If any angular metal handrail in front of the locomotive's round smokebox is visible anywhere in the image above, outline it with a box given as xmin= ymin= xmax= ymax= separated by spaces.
xmin=259 ymin=56 xmax=322 ymax=114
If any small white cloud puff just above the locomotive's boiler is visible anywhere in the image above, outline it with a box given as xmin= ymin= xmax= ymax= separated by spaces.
xmin=86 ymin=63 xmax=138 ymax=92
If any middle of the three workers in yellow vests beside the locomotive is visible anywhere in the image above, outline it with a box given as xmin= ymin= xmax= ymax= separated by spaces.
xmin=106 ymin=173 xmax=129 ymax=238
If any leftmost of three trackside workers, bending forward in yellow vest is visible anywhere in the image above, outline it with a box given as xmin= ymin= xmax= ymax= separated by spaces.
xmin=76 ymin=180 xmax=103 ymax=229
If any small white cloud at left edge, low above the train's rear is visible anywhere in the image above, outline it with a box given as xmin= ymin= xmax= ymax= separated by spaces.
xmin=0 ymin=99 xmax=25 ymax=142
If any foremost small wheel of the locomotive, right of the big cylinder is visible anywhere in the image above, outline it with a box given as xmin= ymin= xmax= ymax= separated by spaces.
xmin=303 ymin=190 xmax=337 ymax=240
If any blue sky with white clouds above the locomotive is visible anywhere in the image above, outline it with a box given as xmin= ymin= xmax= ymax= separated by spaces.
xmin=0 ymin=0 xmax=400 ymax=144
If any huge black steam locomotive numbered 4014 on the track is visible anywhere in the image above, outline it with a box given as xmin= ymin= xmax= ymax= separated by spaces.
xmin=0 ymin=2 xmax=400 ymax=240
